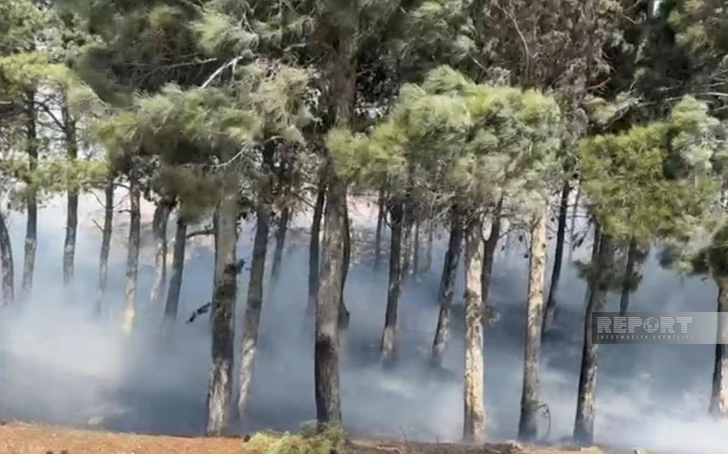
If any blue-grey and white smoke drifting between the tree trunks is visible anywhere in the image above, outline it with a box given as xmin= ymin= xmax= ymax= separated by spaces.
xmin=0 ymin=191 xmax=728 ymax=454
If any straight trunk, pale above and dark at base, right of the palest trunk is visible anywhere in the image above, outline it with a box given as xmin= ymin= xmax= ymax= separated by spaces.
xmin=518 ymin=207 xmax=547 ymax=442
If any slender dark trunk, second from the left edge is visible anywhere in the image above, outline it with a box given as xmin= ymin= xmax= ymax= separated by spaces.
xmin=21 ymin=90 xmax=38 ymax=298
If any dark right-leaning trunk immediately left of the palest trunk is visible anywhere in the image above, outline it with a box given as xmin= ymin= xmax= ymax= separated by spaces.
xmin=431 ymin=207 xmax=463 ymax=367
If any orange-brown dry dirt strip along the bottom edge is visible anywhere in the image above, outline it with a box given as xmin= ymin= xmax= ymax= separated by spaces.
xmin=0 ymin=422 xmax=631 ymax=454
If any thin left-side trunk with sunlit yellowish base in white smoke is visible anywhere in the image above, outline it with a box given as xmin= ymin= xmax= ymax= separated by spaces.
xmin=122 ymin=177 xmax=141 ymax=334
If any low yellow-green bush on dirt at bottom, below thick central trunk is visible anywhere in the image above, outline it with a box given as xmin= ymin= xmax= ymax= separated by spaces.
xmin=245 ymin=421 xmax=346 ymax=454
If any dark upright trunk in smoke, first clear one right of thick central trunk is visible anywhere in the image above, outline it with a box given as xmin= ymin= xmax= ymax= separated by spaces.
xmin=380 ymin=201 xmax=403 ymax=365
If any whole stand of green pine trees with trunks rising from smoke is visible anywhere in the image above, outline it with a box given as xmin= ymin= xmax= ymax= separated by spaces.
xmin=0 ymin=0 xmax=728 ymax=445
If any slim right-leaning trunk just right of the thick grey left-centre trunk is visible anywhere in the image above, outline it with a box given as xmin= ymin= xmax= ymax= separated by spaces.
xmin=236 ymin=142 xmax=276 ymax=417
